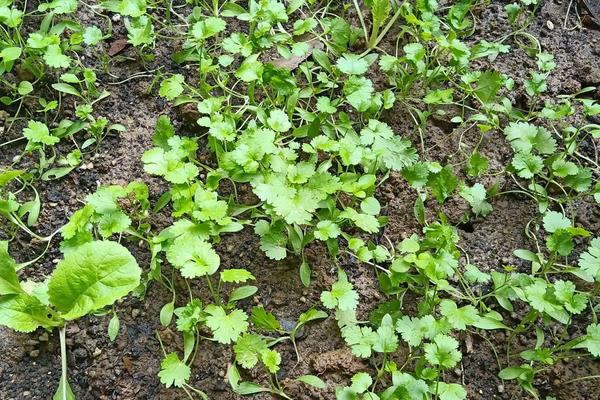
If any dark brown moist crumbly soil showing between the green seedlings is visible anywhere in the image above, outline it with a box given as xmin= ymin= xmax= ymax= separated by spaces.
xmin=0 ymin=0 xmax=600 ymax=400
